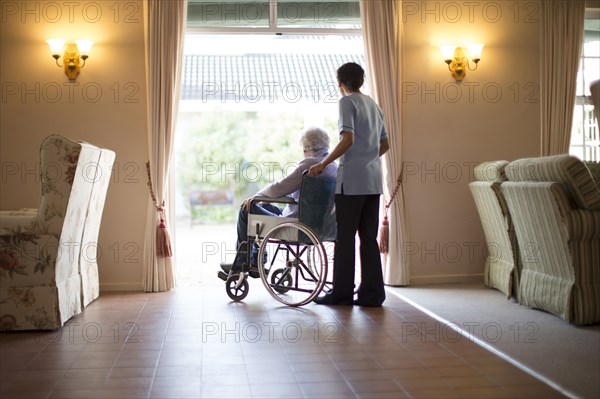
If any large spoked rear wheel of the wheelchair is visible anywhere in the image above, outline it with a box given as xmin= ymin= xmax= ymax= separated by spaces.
xmin=258 ymin=222 xmax=327 ymax=306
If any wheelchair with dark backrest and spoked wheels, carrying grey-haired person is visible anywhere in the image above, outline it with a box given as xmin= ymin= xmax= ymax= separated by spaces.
xmin=218 ymin=172 xmax=337 ymax=306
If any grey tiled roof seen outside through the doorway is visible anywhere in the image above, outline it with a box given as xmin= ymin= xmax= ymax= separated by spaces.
xmin=181 ymin=54 xmax=365 ymax=103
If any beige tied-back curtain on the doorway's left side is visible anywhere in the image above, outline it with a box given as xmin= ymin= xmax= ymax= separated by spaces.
xmin=143 ymin=0 xmax=187 ymax=292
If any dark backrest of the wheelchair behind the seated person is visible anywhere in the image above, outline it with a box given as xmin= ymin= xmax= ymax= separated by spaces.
xmin=298 ymin=174 xmax=337 ymax=242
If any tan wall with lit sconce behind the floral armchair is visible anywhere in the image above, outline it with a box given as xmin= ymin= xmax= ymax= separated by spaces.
xmin=0 ymin=0 xmax=148 ymax=289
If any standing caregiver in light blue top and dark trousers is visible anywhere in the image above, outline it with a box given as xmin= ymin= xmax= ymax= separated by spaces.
xmin=309 ymin=62 xmax=389 ymax=307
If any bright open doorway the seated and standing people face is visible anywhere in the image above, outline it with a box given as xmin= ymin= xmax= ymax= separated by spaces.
xmin=172 ymin=34 xmax=364 ymax=286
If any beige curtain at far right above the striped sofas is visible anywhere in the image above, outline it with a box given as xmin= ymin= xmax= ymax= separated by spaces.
xmin=539 ymin=0 xmax=585 ymax=156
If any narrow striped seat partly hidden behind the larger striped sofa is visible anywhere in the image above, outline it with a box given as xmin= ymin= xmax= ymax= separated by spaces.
xmin=469 ymin=161 xmax=519 ymax=298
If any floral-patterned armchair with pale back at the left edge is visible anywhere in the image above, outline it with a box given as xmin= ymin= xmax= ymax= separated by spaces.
xmin=0 ymin=135 xmax=114 ymax=330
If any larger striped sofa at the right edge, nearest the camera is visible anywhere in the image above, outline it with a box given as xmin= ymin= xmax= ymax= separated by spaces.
xmin=500 ymin=155 xmax=600 ymax=324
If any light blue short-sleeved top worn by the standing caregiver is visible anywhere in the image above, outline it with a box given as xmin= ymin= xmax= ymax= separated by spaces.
xmin=335 ymin=93 xmax=388 ymax=195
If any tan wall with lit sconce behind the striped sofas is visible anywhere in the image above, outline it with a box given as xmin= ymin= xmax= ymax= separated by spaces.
xmin=403 ymin=1 xmax=540 ymax=284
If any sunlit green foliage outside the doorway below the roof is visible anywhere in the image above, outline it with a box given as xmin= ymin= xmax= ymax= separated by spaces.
xmin=175 ymin=111 xmax=337 ymax=223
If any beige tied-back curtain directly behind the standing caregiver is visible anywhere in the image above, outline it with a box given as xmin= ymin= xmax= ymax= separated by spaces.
xmin=360 ymin=0 xmax=410 ymax=285
